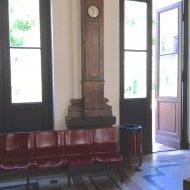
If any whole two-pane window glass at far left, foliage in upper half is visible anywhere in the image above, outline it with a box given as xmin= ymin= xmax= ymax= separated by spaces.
xmin=9 ymin=0 xmax=42 ymax=103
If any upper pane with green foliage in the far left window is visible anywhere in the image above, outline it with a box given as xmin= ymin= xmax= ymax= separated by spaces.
xmin=9 ymin=0 xmax=40 ymax=47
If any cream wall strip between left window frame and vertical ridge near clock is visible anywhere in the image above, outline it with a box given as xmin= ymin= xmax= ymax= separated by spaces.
xmin=52 ymin=0 xmax=74 ymax=129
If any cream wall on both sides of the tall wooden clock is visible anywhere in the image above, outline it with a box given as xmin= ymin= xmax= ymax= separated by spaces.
xmin=51 ymin=0 xmax=119 ymax=130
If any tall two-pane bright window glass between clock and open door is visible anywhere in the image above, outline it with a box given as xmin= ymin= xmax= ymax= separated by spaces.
xmin=124 ymin=0 xmax=147 ymax=98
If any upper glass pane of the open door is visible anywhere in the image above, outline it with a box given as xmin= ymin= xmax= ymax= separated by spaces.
xmin=160 ymin=8 xmax=178 ymax=55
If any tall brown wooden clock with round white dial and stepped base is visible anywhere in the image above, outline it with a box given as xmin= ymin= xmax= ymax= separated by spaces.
xmin=66 ymin=0 xmax=116 ymax=128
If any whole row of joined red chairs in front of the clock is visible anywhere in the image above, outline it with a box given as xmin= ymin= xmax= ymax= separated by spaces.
xmin=0 ymin=127 xmax=123 ymax=189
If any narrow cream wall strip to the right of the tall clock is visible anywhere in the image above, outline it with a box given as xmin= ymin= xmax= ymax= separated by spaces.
xmin=104 ymin=0 xmax=120 ymax=126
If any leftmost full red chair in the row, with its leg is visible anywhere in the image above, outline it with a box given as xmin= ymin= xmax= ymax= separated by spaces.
xmin=1 ymin=133 xmax=32 ymax=189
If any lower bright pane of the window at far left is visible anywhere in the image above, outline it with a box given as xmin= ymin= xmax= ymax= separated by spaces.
xmin=10 ymin=48 xmax=42 ymax=103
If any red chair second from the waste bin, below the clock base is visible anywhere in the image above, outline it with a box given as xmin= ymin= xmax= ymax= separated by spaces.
xmin=65 ymin=129 xmax=94 ymax=166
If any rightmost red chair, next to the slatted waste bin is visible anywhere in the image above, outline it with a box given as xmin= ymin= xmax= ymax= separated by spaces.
xmin=94 ymin=127 xmax=123 ymax=181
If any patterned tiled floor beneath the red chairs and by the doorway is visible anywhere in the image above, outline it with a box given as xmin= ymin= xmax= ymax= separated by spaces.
xmin=0 ymin=150 xmax=190 ymax=190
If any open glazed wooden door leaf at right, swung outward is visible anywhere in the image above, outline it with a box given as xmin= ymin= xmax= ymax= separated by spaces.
xmin=155 ymin=2 xmax=183 ymax=148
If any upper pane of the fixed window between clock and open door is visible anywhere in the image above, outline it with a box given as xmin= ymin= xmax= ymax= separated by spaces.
xmin=124 ymin=0 xmax=147 ymax=50
